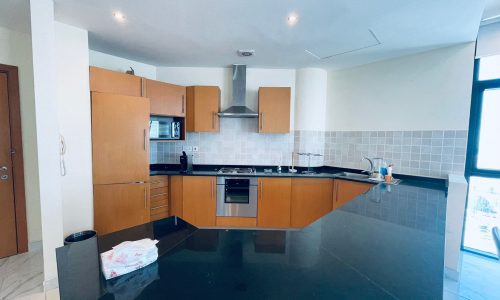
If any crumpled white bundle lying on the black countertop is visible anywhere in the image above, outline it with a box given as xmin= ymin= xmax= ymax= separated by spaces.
xmin=101 ymin=239 xmax=158 ymax=279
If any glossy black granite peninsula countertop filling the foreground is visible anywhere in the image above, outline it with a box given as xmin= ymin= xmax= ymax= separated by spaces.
xmin=57 ymin=175 xmax=446 ymax=299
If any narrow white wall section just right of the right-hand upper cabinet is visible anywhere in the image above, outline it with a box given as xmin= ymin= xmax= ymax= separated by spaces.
xmin=295 ymin=68 xmax=327 ymax=131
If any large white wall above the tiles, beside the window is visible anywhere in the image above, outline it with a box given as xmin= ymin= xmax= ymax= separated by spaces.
xmin=326 ymin=43 xmax=474 ymax=131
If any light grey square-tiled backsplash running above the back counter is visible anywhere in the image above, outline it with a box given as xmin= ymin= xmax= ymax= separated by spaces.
xmin=151 ymin=119 xmax=467 ymax=178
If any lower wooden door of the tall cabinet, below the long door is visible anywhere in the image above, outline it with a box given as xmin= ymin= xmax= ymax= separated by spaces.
xmin=94 ymin=183 xmax=150 ymax=235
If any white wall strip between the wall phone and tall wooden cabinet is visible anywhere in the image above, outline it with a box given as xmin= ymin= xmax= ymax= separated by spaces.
xmin=55 ymin=22 xmax=94 ymax=236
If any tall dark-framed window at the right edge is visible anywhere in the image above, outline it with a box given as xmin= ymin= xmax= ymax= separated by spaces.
xmin=463 ymin=56 xmax=500 ymax=256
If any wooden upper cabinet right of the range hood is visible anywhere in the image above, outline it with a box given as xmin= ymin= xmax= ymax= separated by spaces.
xmin=259 ymin=87 xmax=291 ymax=133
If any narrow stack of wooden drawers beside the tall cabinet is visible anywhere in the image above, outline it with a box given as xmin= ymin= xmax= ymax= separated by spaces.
xmin=149 ymin=176 xmax=170 ymax=221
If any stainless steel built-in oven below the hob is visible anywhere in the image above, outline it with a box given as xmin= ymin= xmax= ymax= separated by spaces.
xmin=217 ymin=176 xmax=257 ymax=218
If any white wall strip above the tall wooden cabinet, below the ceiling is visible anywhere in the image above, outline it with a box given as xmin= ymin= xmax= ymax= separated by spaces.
xmin=89 ymin=50 xmax=156 ymax=79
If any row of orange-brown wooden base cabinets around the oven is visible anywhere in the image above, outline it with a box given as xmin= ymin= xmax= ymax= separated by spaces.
xmin=162 ymin=176 xmax=373 ymax=228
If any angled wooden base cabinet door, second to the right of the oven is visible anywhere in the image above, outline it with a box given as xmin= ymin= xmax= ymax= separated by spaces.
xmin=291 ymin=178 xmax=333 ymax=227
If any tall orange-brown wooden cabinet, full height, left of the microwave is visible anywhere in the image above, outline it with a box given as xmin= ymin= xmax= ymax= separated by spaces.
xmin=90 ymin=67 xmax=150 ymax=235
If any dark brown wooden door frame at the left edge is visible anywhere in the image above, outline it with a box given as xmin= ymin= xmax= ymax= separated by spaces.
xmin=0 ymin=64 xmax=28 ymax=253
